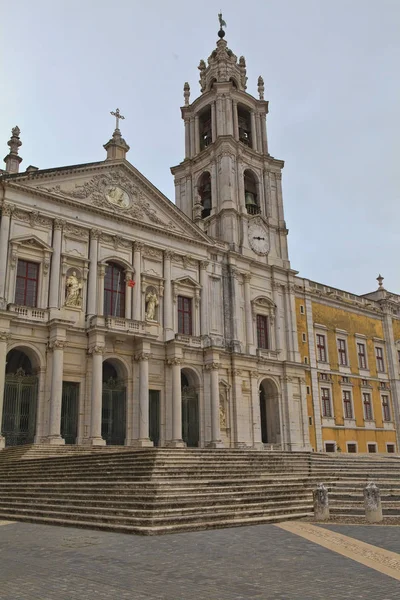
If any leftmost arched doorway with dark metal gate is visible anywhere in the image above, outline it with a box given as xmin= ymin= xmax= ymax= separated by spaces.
xmin=2 ymin=349 xmax=38 ymax=446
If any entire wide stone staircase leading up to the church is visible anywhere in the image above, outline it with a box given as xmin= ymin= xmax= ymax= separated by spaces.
xmin=0 ymin=445 xmax=400 ymax=535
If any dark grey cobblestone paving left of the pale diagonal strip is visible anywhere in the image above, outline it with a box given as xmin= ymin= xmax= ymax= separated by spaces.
xmin=0 ymin=523 xmax=400 ymax=600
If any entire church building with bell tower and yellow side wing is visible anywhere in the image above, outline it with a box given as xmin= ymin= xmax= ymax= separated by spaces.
xmin=0 ymin=31 xmax=400 ymax=452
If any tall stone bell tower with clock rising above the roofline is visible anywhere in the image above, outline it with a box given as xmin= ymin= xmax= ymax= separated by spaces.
xmin=171 ymin=17 xmax=289 ymax=268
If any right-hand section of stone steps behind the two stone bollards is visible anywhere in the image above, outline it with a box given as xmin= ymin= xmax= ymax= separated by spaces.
xmin=311 ymin=454 xmax=400 ymax=519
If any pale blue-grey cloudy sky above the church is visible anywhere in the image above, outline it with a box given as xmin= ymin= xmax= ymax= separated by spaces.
xmin=0 ymin=0 xmax=400 ymax=294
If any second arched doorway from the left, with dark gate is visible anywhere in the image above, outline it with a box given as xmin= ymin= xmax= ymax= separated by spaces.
xmin=101 ymin=360 xmax=126 ymax=446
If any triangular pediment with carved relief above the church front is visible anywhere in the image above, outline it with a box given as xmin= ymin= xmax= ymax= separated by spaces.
xmin=13 ymin=160 xmax=212 ymax=244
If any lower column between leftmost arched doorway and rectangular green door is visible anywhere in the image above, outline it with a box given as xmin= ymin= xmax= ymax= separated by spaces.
xmin=47 ymin=340 xmax=65 ymax=445
